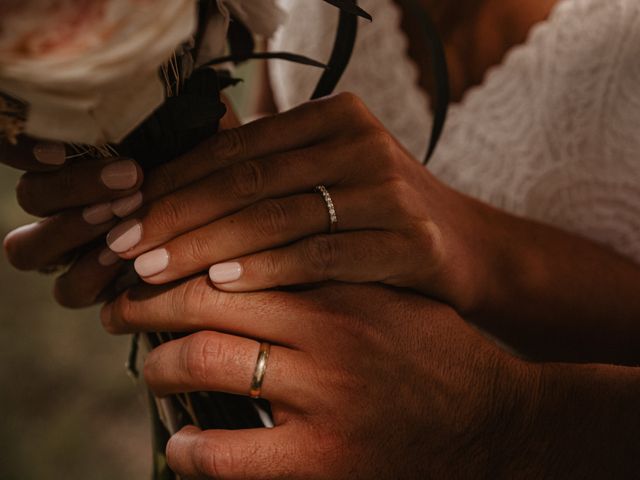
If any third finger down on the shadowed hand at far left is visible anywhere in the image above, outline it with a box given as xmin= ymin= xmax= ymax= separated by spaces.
xmin=4 ymin=211 xmax=116 ymax=270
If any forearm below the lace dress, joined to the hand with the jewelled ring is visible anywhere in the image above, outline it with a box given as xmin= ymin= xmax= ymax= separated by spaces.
xmin=470 ymin=200 xmax=640 ymax=364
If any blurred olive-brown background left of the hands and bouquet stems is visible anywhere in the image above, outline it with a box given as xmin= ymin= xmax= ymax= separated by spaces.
xmin=0 ymin=79 xmax=253 ymax=480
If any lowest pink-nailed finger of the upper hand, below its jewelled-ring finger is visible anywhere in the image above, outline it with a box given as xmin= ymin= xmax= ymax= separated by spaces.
xmin=209 ymin=230 xmax=416 ymax=292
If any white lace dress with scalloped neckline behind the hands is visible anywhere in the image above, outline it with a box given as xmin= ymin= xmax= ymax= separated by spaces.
xmin=270 ymin=0 xmax=640 ymax=262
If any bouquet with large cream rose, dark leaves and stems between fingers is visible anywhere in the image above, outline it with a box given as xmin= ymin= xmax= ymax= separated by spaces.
xmin=0 ymin=0 xmax=378 ymax=479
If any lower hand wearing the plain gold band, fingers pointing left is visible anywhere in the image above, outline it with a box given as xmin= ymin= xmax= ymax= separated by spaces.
xmin=102 ymin=277 xmax=539 ymax=479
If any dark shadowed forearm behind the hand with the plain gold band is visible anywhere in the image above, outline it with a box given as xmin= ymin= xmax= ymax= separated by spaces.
xmin=495 ymin=364 xmax=640 ymax=479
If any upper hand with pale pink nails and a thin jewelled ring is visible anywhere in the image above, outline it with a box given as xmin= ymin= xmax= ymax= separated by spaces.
xmin=108 ymin=94 xmax=493 ymax=311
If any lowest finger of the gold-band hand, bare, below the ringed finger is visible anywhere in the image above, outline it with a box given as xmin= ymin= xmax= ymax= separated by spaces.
xmin=167 ymin=423 xmax=312 ymax=480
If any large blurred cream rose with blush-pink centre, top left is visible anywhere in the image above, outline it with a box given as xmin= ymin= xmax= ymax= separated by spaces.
xmin=0 ymin=0 xmax=197 ymax=145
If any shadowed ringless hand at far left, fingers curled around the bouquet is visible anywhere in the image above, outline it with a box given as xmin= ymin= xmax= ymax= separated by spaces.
xmin=0 ymin=100 xmax=240 ymax=308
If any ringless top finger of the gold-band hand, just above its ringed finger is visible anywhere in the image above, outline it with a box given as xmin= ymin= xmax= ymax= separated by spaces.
xmin=100 ymin=275 xmax=304 ymax=346
